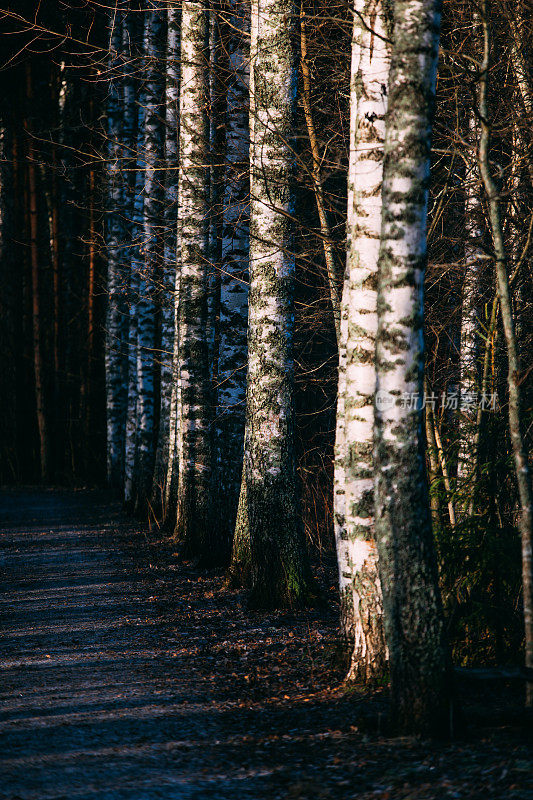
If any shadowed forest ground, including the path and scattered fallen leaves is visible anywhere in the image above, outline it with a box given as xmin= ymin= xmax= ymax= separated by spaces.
xmin=0 ymin=489 xmax=533 ymax=800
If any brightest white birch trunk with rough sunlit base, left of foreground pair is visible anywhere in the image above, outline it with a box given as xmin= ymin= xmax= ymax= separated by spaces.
xmin=335 ymin=0 xmax=392 ymax=682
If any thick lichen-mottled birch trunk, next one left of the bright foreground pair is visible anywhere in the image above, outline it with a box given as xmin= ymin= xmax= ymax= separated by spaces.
xmin=231 ymin=0 xmax=311 ymax=607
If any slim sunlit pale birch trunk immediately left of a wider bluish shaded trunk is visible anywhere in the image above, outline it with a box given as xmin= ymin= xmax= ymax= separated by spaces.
xmin=172 ymin=0 xmax=211 ymax=558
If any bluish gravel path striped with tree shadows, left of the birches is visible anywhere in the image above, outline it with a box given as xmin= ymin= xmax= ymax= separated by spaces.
xmin=0 ymin=492 xmax=272 ymax=800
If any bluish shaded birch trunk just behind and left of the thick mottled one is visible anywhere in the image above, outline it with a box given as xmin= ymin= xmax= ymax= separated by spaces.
xmin=215 ymin=0 xmax=250 ymax=557
